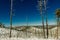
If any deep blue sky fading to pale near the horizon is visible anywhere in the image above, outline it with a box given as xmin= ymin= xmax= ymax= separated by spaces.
xmin=0 ymin=0 xmax=60 ymax=26
